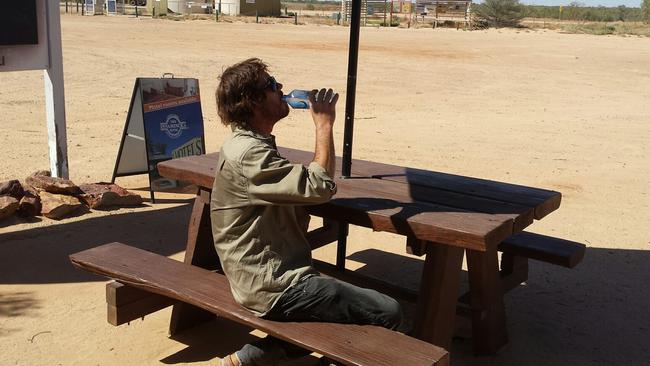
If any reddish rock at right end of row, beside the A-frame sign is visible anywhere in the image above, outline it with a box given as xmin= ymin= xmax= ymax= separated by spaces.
xmin=79 ymin=183 xmax=142 ymax=209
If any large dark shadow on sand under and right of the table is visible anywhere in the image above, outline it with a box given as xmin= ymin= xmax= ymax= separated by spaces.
xmin=348 ymin=248 xmax=650 ymax=365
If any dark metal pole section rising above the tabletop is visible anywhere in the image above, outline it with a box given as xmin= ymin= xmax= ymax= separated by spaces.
xmin=341 ymin=0 xmax=361 ymax=178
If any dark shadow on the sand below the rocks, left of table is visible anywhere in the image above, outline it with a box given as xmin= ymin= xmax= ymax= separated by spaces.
xmin=0 ymin=201 xmax=192 ymax=284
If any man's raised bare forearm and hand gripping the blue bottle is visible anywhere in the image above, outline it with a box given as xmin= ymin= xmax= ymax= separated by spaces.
xmin=309 ymin=89 xmax=339 ymax=178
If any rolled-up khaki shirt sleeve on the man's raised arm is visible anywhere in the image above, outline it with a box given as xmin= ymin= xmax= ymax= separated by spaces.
xmin=241 ymin=146 xmax=336 ymax=205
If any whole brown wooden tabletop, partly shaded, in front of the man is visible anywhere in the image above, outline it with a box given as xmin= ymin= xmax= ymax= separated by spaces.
xmin=158 ymin=148 xmax=561 ymax=251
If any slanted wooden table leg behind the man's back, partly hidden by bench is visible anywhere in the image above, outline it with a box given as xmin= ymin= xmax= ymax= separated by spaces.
xmin=169 ymin=189 xmax=220 ymax=336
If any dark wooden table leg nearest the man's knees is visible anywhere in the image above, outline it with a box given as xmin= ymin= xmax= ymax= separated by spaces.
xmin=413 ymin=242 xmax=463 ymax=349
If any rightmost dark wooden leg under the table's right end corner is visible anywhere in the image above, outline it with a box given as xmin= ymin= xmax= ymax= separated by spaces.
xmin=467 ymin=248 xmax=508 ymax=355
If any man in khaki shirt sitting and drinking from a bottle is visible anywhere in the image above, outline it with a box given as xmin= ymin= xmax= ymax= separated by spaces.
xmin=211 ymin=59 xmax=402 ymax=366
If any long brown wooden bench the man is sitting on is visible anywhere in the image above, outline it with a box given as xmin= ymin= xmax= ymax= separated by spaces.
xmin=70 ymin=243 xmax=449 ymax=366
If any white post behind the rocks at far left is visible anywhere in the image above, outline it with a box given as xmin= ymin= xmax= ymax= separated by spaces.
xmin=43 ymin=0 xmax=69 ymax=179
